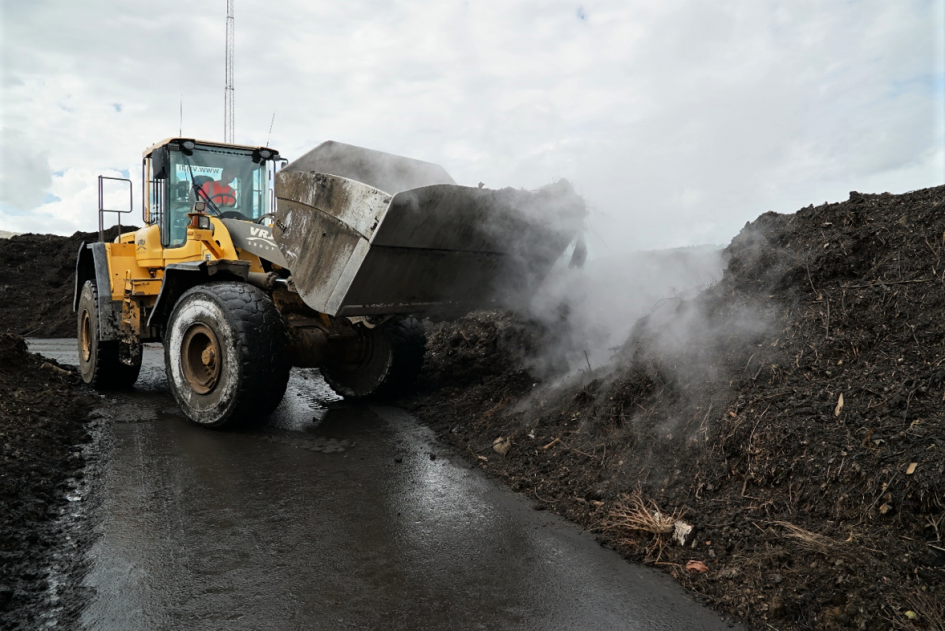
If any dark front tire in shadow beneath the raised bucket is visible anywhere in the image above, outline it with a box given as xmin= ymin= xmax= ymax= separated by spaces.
xmin=321 ymin=318 xmax=427 ymax=399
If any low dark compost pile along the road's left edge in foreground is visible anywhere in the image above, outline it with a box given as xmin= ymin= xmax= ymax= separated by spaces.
xmin=0 ymin=333 xmax=95 ymax=628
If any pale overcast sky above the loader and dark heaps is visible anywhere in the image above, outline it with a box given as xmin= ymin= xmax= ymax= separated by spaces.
xmin=0 ymin=0 xmax=945 ymax=255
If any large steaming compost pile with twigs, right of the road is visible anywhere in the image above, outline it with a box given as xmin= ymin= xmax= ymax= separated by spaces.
xmin=407 ymin=187 xmax=945 ymax=629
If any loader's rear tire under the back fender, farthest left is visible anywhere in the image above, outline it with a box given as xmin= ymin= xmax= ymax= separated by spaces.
xmin=76 ymin=280 xmax=141 ymax=390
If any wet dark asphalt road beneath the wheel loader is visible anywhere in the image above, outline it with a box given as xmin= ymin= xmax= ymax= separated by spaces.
xmin=30 ymin=340 xmax=733 ymax=630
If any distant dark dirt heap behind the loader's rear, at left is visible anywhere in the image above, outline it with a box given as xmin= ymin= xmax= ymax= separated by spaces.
xmin=0 ymin=226 xmax=137 ymax=337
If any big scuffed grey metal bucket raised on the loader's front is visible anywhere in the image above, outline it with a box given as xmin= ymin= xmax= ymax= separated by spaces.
xmin=273 ymin=143 xmax=585 ymax=318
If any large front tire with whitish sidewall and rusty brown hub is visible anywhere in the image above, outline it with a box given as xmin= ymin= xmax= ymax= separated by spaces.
xmin=164 ymin=282 xmax=289 ymax=428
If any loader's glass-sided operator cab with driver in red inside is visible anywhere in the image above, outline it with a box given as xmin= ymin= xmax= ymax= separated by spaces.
xmin=141 ymin=138 xmax=286 ymax=248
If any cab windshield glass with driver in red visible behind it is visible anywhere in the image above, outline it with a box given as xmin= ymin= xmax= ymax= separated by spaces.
xmin=167 ymin=144 xmax=269 ymax=247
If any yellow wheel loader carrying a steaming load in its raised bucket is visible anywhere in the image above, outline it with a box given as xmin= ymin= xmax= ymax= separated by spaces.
xmin=74 ymin=138 xmax=586 ymax=427
